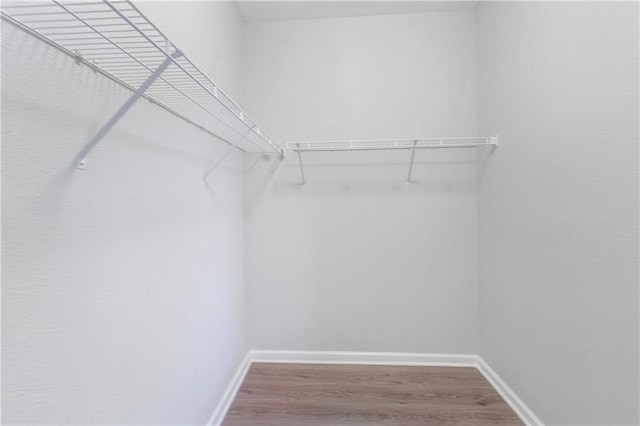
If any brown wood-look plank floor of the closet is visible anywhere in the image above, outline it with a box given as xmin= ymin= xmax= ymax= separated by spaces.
xmin=223 ymin=363 xmax=523 ymax=426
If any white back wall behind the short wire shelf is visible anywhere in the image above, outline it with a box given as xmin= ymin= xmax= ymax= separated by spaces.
xmin=243 ymin=10 xmax=478 ymax=353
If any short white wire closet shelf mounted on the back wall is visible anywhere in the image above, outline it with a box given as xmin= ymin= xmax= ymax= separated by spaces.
xmin=287 ymin=136 xmax=498 ymax=184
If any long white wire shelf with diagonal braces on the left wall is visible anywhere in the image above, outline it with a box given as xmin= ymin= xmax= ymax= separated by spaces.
xmin=2 ymin=0 xmax=283 ymax=171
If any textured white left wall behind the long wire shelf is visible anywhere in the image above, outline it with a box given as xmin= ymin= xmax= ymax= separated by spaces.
xmin=2 ymin=3 xmax=247 ymax=424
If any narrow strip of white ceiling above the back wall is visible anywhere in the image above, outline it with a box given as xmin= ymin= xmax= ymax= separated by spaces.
xmin=235 ymin=0 xmax=478 ymax=22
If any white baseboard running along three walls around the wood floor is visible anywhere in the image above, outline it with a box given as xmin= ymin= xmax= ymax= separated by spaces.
xmin=207 ymin=350 xmax=543 ymax=426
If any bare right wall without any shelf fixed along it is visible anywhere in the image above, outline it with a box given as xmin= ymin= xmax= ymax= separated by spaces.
xmin=478 ymin=2 xmax=640 ymax=425
